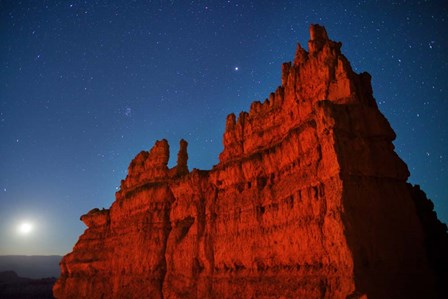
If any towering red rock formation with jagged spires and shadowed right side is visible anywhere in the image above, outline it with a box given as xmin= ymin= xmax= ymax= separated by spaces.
xmin=54 ymin=25 xmax=448 ymax=298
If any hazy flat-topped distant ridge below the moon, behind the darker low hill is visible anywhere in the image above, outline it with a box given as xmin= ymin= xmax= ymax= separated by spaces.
xmin=0 ymin=255 xmax=62 ymax=279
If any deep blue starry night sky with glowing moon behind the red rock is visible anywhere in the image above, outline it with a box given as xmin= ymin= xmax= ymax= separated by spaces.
xmin=0 ymin=0 xmax=448 ymax=255
